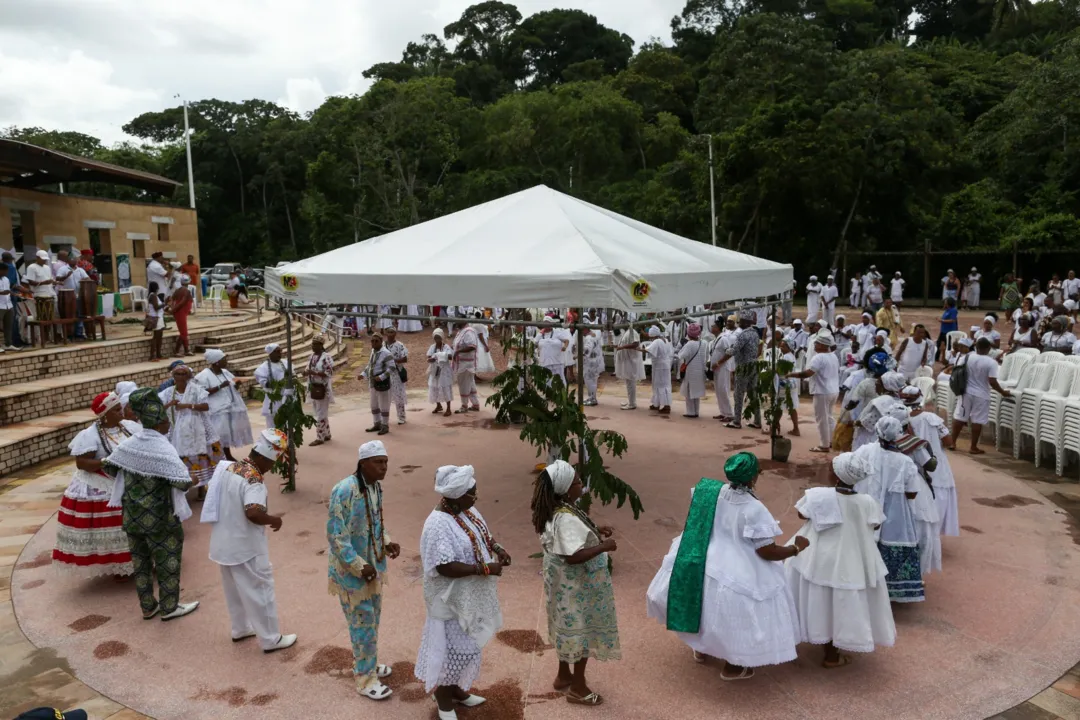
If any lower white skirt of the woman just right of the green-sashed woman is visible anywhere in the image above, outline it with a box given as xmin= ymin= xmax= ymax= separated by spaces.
xmin=785 ymin=566 xmax=896 ymax=652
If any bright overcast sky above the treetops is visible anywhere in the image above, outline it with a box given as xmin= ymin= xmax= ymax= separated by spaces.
xmin=0 ymin=0 xmax=685 ymax=142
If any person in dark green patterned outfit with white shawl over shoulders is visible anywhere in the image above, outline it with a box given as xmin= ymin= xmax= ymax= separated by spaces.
xmin=103 ymin=388 xmax=199 ymax=621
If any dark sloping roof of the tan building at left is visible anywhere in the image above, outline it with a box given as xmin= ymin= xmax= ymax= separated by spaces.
xmin=0 ymin=138 xmax=180 ymax=195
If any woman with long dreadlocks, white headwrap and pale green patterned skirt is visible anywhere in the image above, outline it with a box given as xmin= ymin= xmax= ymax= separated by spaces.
xmin=532 ymin=460 xmax=622 ymax=705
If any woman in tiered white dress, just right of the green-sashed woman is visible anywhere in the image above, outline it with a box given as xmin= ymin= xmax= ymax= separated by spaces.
xmin=784 ymin=452 xmax=896 ymax=668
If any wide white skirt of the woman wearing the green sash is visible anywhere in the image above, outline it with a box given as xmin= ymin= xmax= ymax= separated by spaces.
xmin=646 ymin=553 xmax=799 ymax=667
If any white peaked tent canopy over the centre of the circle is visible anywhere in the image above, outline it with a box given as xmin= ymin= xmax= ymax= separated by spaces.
xmin=266 ymin=186 xmax=792 ymax=311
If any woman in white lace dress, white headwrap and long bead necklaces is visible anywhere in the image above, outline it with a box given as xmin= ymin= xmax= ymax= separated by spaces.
xmin=416 ymin=465 xmax=510 ymax=720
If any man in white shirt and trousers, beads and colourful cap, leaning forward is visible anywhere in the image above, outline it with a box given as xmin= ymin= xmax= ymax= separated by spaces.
xmin=200 ymin=430 xmax=296 ymax=653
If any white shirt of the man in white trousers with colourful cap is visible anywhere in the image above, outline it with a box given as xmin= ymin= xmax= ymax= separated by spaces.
xmin=210 ymin=463 xmax=270 ymax=566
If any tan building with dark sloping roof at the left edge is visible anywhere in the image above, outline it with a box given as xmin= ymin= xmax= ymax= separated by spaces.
xmin=0 ymin=139 xmax=199 ymax=290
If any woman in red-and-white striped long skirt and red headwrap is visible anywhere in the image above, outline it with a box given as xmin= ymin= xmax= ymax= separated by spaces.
xmin=53 ymin=393 xmax=134 ymax=578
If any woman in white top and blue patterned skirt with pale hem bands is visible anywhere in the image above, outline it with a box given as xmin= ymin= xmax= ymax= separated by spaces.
xmin=855 ymin=416 xmax=926 ymax=602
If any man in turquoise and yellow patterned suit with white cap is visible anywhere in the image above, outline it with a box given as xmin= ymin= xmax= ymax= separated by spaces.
xmin=326 ymin=440 xmax=401 ymax=701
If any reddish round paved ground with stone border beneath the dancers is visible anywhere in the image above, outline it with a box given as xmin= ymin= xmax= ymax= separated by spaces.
xmin=6 ymin=371 xmax=1080 ymax=720
